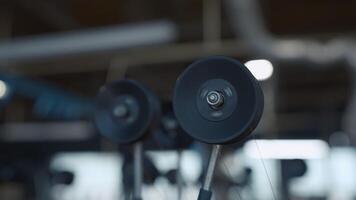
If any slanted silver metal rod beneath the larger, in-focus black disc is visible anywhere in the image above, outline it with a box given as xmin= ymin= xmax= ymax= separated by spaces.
xmin=203 ymin=145 xmax=221 ymax=191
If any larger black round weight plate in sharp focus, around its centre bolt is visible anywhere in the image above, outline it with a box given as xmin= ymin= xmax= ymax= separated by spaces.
xmin=173 ymin=56 xmax=263 ymax=144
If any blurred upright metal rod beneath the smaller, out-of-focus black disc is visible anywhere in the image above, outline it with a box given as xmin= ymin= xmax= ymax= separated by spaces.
xmin=134 ymin=142 xmax=143 ymax=200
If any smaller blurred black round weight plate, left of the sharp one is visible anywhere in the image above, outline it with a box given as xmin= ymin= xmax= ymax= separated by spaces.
xmin=94 ymin=79 xmax=160 ymax=144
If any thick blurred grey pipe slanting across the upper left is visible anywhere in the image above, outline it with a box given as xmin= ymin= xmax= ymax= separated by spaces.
xmin=0 ymin=21 xmax=177 ymax=62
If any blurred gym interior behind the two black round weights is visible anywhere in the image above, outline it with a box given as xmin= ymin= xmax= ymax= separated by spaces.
xmin=0 ymin=0 xmax=356 ymax=200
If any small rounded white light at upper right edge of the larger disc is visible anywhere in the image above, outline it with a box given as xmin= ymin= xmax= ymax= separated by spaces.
xmin=245 ymin=60 xmax=273 ymax=81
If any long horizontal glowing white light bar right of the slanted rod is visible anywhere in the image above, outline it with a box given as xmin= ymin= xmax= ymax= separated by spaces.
xmin=243 ymin=140 xmax=329 ymax=159
